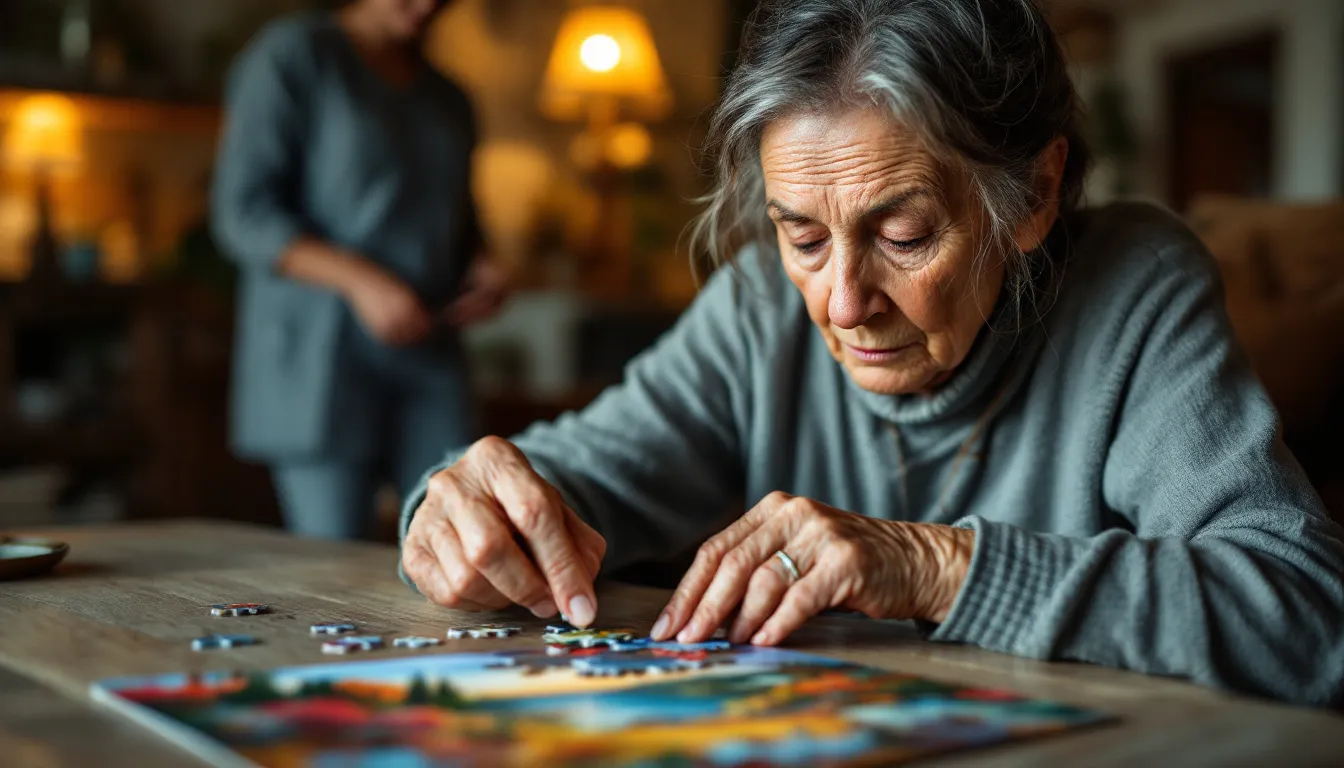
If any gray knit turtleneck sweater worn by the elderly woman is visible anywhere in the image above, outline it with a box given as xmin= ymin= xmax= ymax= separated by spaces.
xmin=402 ymin=204 xmax=1344 ymax=703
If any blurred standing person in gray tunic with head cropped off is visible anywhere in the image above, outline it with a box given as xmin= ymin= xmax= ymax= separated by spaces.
xmin=211 ymin=0 xmax=507 ymax=538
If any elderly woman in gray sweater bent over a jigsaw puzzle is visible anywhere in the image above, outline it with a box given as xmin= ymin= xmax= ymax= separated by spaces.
xmin=402 ymin=0 xmax=1344 ymax=703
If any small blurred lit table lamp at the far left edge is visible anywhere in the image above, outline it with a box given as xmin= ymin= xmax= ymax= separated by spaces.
xmin=4 ymin=94 xmax=83 ymax=281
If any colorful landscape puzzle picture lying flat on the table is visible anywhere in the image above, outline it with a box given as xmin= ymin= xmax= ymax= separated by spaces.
xmin=93 ymin=647 xmax=1105 ymax=768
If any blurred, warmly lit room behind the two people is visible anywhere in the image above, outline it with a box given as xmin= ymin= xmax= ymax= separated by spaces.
xmin=0 ymin=0 xmax=1344 ymax=537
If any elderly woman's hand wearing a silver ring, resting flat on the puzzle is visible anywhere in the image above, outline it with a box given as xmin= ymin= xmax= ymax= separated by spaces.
xmin=652 ymin=492 xmax=974 ymax=646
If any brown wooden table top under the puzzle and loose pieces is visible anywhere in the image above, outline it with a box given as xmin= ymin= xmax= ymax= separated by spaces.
xmin=0 ymin=522 xmax=1344 ymax=768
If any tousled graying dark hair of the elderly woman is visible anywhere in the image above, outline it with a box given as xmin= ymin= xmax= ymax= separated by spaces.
xmin=691 ymin=0 xmax=1089 ymax=315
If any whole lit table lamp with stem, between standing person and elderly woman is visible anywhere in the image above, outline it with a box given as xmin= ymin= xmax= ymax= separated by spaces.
xmin=539 ymin=5 xmax=672 ymax=292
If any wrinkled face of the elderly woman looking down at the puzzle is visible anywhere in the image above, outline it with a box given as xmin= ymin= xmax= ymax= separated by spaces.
xmin=761 ymin=109 xmax=1004 ymax=394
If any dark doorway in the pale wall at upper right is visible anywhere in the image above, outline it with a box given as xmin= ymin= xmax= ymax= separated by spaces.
xmin=1167 ymin=31 xmax=1279 ymax=211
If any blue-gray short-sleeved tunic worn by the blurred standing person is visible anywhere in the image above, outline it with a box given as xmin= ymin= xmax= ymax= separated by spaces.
xmin=211 ymin=15 xmax=481 ymax=460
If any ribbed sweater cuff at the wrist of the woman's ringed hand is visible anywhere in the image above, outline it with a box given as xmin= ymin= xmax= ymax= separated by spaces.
xmin=929 ymin=515 xmax=1075 ymax=658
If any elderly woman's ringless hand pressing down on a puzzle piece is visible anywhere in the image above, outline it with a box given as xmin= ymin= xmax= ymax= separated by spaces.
xmin=402 ymin=437 xmax=606 ymax=627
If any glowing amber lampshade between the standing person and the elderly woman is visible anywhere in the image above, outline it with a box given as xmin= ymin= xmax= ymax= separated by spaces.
xmin=540 ymin=5 xmax=672 ymax=121
